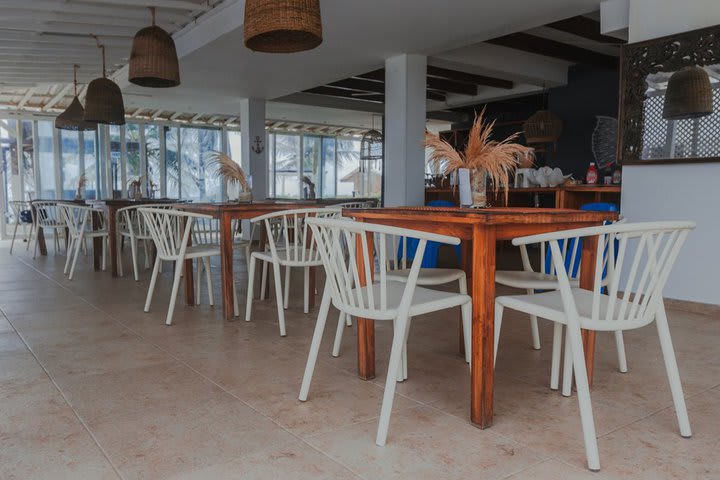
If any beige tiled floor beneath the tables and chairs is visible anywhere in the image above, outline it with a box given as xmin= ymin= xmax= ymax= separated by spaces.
xmin=0 ymin=242 xmax=720 ymax=480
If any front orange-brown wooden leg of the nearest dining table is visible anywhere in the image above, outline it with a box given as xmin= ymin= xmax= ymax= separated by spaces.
xmin=470 ymin=224 xmax=495 ymax=428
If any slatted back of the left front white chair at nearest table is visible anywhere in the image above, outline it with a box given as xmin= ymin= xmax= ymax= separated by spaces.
xmin=307 ymin=218 xmax=460 ymax=320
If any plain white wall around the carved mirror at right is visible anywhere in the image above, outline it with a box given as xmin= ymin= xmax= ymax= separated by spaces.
xmin=622 ymin=0 xmax=720 ymax=305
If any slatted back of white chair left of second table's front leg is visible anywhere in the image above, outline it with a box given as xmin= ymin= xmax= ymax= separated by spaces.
xmin=138 ymin=207 xmax=211 ymax=261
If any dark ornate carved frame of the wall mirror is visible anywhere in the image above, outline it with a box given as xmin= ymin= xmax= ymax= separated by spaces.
xmin=617 ymin=25 xmax=720 ymax=165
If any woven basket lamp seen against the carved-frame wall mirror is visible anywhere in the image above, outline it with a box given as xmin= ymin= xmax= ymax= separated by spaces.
xmin=663 ymin=67 xmax=713 ymax=120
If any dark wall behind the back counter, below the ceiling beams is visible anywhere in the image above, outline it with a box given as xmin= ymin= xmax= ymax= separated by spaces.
xmin=444 ymin=65 xmax=619 ymax=179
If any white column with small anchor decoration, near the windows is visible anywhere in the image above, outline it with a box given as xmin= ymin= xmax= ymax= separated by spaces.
xmin=240 ymin=98 xmax=268 ymax=200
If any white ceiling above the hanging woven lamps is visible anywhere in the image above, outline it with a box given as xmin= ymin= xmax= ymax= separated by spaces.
xmin=0 ymin=0 xmax=600 ymax=125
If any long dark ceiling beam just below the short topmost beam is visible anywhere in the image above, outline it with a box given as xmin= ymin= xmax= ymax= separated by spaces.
xmin=487 ymin=32 xmax=618 ymax=69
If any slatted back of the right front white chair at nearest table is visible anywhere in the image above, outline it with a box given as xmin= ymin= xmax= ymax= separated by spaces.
xmin=513 ymin=222 xmax=695 ymax=331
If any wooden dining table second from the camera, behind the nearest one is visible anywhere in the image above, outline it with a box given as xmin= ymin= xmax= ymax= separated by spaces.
xmin=176 ymin=200 xmax=334 ymax=320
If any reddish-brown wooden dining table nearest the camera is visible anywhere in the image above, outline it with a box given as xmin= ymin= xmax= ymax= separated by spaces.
xmin=343 ymin=207 xmax=617 ymax=428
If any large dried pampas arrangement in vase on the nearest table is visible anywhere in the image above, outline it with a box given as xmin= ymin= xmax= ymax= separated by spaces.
xmin=425 ymin=110 xmax=532 ymax=207
